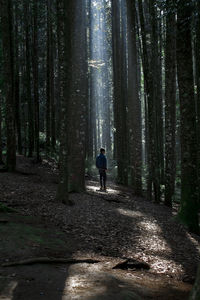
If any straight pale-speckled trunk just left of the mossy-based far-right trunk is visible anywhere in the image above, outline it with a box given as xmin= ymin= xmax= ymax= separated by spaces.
xmin=165 ymin=0 xmax=176 ymax=207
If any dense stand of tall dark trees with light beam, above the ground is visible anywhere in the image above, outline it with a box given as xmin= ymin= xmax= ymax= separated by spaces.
xmin=0 ymin=0 xmax=200 ymax=233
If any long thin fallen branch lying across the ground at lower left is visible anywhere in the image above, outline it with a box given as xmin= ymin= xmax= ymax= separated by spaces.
xmin=2 ymin=257 xmax=99 ymax=267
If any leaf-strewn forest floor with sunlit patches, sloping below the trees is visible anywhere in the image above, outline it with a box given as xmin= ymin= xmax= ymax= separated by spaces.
xmin=0 ymin=156 xmax=200 ymax=300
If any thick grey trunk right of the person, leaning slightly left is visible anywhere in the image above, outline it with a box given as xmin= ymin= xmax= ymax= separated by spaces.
xmin=127 ymin=0 xmax=142 ymax=195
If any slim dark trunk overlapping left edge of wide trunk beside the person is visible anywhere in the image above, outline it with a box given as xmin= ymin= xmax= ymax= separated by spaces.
xmin=56 ymin=0 xmax=76 ymax=205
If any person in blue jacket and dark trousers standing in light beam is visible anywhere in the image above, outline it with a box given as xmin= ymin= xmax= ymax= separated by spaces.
xmin=96 ymin=148 xmax=107 ymax=192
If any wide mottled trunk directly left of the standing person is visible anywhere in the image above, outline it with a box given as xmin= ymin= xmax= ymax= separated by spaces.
xmin=68 ymin=0 xmax=88 ymax=192
